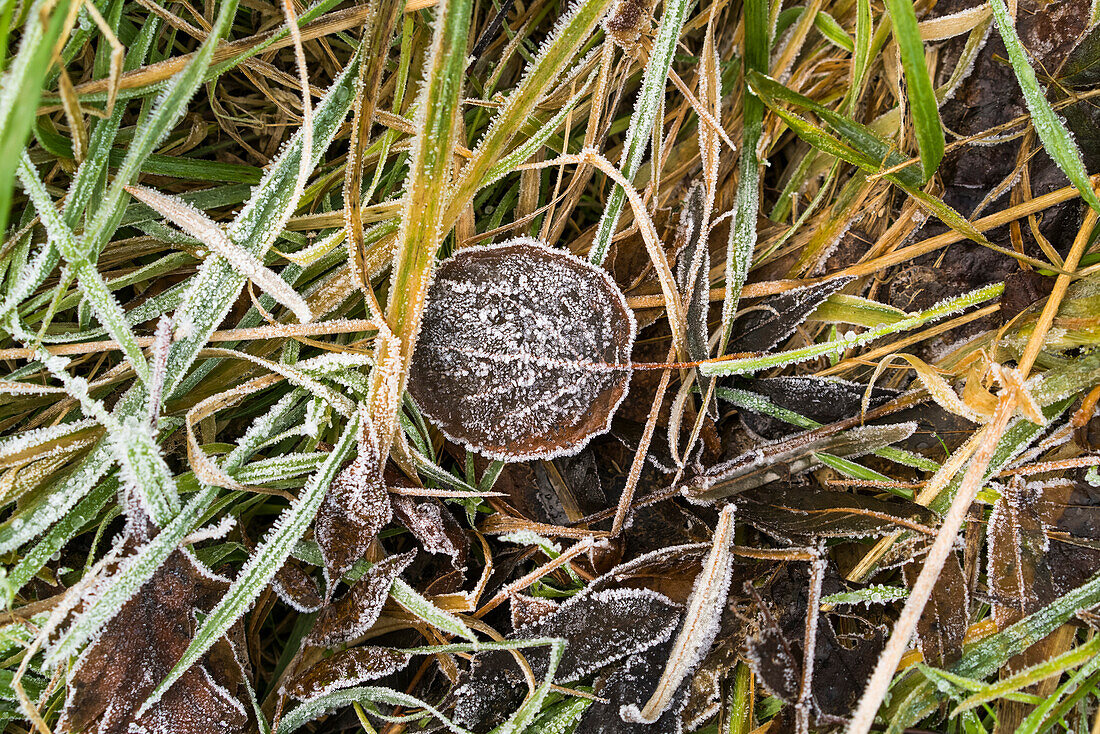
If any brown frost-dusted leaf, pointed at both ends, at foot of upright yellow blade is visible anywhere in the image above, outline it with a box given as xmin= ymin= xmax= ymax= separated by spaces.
xmin=315 ymin=416 xmax=393 ymax=595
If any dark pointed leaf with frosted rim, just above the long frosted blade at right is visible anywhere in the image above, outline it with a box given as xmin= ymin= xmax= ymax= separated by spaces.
xmin=727 ymin=275 xmax=856 ymax=352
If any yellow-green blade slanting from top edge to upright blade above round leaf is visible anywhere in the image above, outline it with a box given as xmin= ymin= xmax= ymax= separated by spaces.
xmin=442 ymin=0 xmax=614 ymax=230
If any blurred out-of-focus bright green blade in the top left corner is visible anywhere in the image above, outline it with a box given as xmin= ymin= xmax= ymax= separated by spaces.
xmin=0 ymin=0 xmax=70 ymax=239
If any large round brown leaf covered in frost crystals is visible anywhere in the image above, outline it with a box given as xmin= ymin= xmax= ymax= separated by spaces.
xmin=408 ymin=238 xmax=635 ymax=460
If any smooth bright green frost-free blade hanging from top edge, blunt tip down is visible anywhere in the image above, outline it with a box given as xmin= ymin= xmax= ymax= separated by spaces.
xmin=886 ymin=0 xmax=945 ymax=184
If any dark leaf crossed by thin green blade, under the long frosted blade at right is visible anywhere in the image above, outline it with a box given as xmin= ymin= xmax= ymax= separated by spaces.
xmin=738 ymin=375 xmax=900 ymax=440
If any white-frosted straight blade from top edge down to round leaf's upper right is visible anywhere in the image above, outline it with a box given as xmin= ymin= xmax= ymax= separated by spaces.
xmin=589 ymin=0 xmax=695 ymax=265
